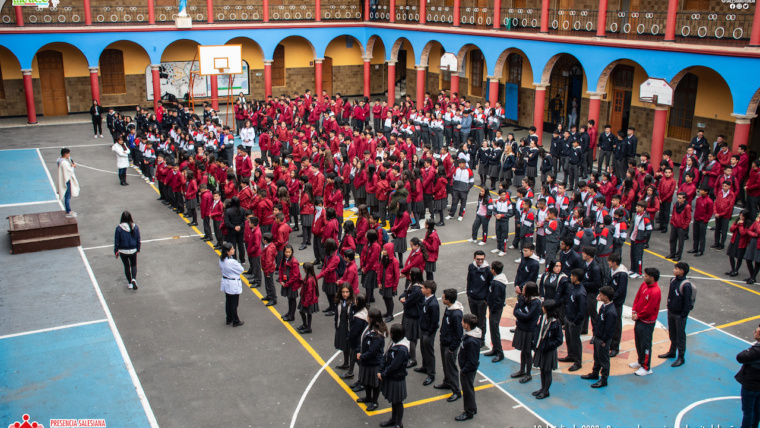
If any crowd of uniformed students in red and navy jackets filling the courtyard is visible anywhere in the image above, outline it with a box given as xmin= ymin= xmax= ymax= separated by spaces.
xmin=98 ymin=91 xmax=744 ymax=426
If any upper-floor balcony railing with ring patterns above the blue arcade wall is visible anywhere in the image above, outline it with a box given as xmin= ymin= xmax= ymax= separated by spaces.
xmin=0 ymin=0 xmax=760 ymax=46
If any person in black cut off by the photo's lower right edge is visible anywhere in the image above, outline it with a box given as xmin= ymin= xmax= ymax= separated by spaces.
xmin=734 ymin=326 xmax=760 ymax=428
